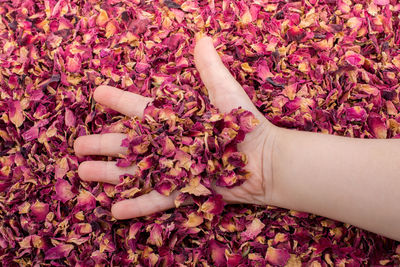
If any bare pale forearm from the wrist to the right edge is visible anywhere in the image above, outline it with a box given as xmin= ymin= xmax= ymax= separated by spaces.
xmin=271 ymin=129 xmax=400 ymax=243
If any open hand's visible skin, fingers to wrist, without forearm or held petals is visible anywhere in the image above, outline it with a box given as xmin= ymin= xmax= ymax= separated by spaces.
xmin=74 ymin=37 xmax=278 ymax=219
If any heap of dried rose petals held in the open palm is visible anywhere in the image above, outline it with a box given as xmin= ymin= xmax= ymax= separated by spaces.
xmin=116 ymin=84 xmax=258 ymax=209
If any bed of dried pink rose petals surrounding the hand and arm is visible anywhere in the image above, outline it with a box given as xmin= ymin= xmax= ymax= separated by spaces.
xmin=0 ymin=0 xmax=400 ymax=266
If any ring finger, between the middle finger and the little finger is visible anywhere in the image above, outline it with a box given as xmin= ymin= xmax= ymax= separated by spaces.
xmin=78 ymin=161 xmax=136 ymax=184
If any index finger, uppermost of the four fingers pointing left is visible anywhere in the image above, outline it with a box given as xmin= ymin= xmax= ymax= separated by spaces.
xmin=94 ymin=85 xmax=152 ymax=117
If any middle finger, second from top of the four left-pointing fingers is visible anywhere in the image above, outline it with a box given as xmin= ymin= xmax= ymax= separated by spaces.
xmin=74 ymin=133 xmax=127 ymax=156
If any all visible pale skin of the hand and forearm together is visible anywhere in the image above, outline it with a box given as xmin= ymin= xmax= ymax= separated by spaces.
xmin=74 ymin=37 xmax=400 ymax=243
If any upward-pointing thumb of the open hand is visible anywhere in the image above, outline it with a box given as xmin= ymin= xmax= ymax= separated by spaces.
xmin=194 ymin=37 xmax=265 ymax=120
